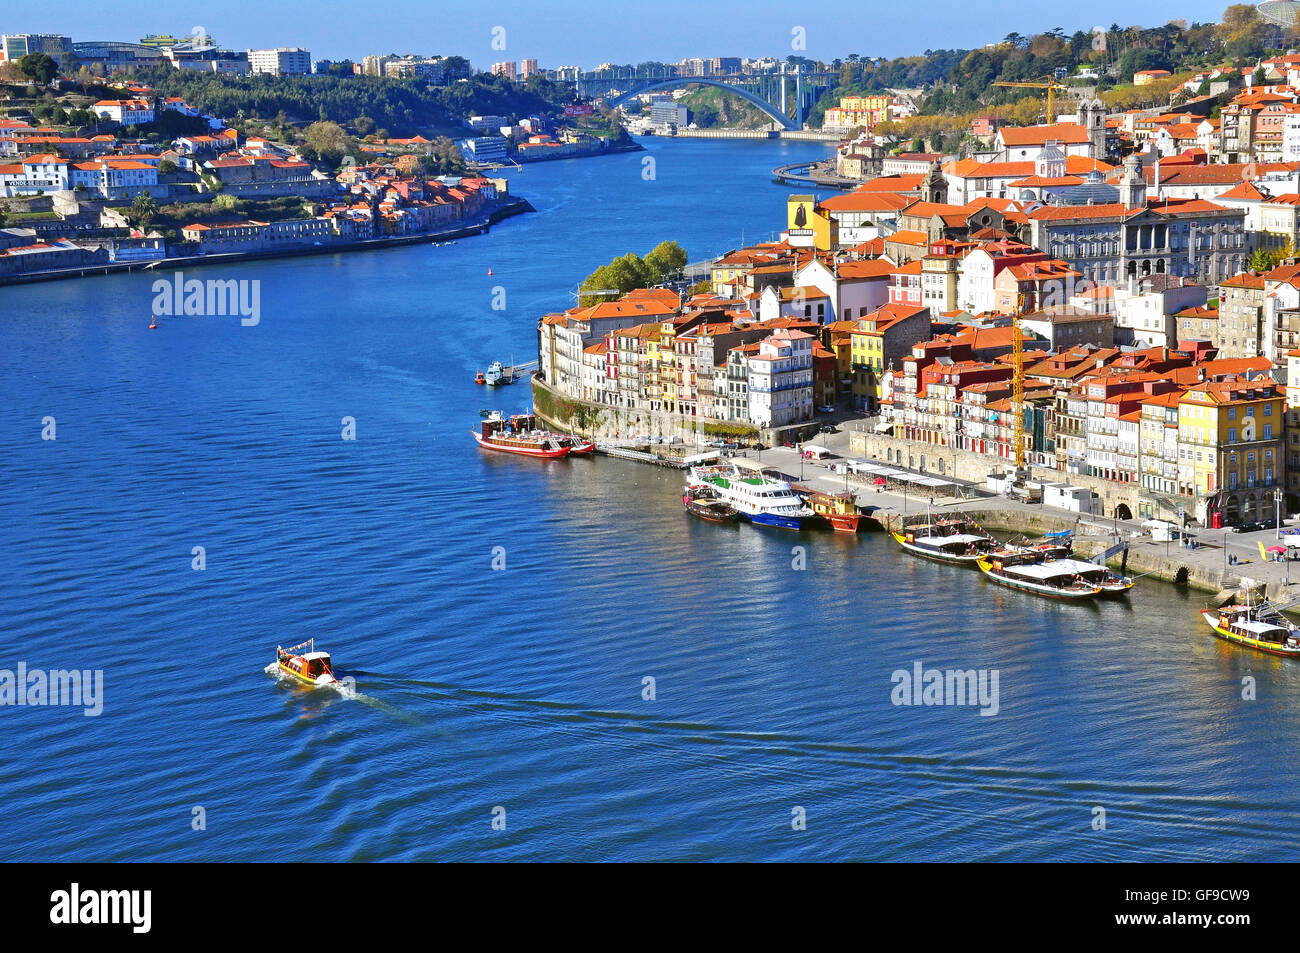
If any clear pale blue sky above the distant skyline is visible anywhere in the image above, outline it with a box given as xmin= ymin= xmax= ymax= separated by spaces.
xmin=0 ymin=0 xmax=1227 ymax=68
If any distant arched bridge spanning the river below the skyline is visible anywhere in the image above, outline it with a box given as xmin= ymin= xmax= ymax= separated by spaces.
xmin=577 ymin=65 xmax=840 ymax=129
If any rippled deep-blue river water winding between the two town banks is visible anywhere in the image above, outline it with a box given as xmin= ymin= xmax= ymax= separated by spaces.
xmin=0 ymin=142 xmax=1300 ymax=861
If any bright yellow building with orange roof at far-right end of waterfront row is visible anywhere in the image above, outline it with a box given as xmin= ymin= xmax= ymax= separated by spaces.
xmin=1178 ymin=378 xmax=1286 ymax=525
